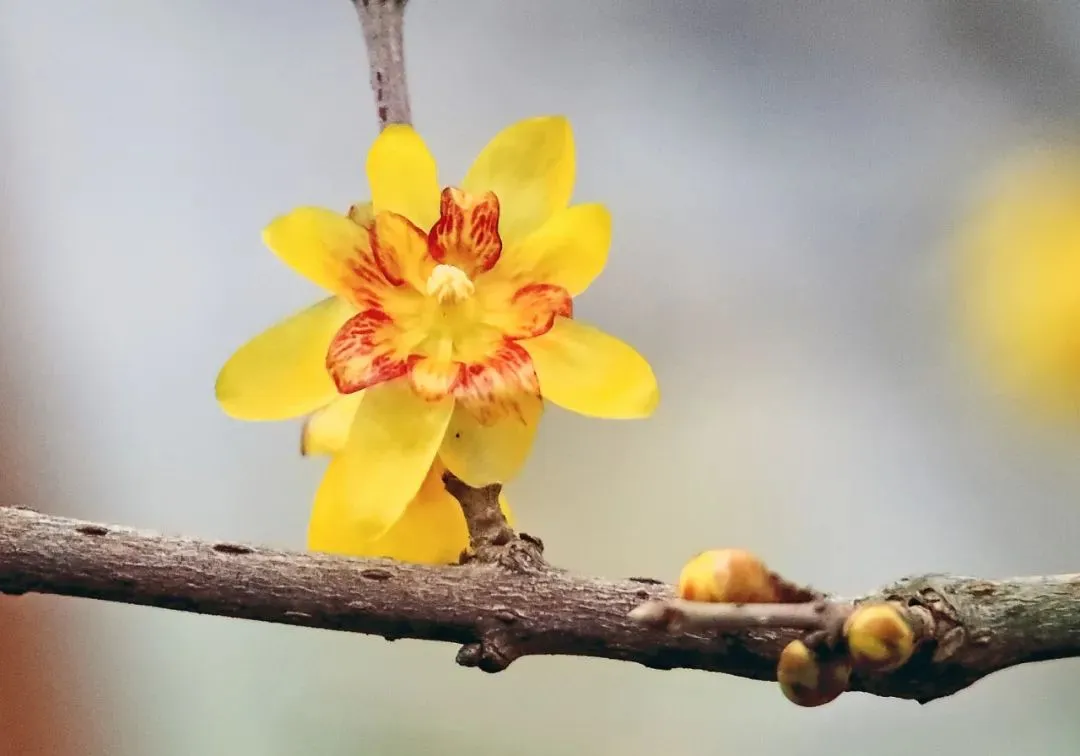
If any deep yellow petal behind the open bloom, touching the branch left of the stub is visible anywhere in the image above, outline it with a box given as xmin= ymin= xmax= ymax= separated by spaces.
xmin=308 ymin=461 xmax=512 ymax=565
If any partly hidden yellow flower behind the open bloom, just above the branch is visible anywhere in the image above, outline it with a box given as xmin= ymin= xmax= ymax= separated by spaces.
xmin=300 ymin=392 xmax=514 ymax=565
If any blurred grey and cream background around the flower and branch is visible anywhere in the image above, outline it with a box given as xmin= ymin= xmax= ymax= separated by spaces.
xmin=0 ymin=0 xmax=1080 ymax=756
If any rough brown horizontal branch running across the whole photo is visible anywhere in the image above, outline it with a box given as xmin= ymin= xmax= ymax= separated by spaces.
xmin=0 ymin=505 xmax=1080 ymax=702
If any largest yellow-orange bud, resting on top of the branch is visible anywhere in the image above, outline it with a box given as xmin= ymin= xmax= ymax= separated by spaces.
xmin=678 ymin=549 xmax=780 ymax=604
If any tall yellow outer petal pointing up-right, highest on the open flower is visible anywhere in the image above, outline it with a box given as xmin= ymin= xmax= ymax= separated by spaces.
xmin=461 ymin=117 xmax=576 ymax=245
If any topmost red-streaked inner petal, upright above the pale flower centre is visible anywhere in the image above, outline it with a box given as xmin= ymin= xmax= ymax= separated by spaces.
xmin=428 ymin=187 xmax=502 ymax=278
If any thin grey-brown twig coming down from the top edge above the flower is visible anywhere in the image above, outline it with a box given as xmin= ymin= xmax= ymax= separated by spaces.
xmin=352 ymin=0 xmax=413 ymax=129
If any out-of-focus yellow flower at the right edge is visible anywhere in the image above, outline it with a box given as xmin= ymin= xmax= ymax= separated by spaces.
xmin=958 ymin=143 xmax=1080 ymax=418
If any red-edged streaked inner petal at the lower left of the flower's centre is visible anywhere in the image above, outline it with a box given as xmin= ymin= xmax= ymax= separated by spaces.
xmin=326 ymin=309 xmax=410 ymax=394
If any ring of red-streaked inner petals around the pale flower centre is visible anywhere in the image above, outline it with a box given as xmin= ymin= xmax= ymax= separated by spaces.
xmin=326 ymin=182 xmax=573 ymax=412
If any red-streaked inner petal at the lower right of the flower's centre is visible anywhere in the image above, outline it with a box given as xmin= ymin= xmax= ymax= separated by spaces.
xmin=454 ymin=340 xmax=540 ymax=422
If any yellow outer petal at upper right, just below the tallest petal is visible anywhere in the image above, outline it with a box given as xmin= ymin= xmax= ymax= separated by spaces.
xmin=491 ymin=204 xmax=611 ymax=297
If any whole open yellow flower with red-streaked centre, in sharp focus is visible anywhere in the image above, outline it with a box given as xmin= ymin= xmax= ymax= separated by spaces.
xmin=211 ymin=118 xmax=659 ymax=541
